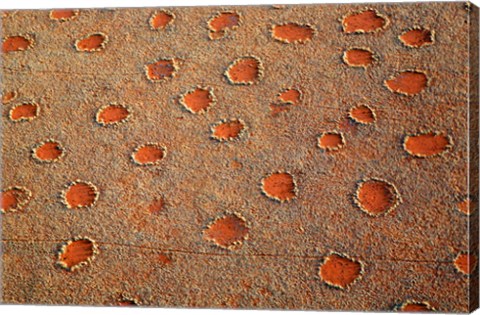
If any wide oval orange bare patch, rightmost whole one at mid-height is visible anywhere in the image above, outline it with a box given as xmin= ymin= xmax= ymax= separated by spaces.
xmin=403 ymin=132 xmax=452 ymax=158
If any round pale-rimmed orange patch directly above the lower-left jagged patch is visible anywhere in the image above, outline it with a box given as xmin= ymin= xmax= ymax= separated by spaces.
xmin=62 ymin=180 xmax=99 ymax=209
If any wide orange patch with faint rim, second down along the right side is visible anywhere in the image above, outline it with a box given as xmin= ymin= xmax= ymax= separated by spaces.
xmin=385 ymin=70 xmax=428 ymax=96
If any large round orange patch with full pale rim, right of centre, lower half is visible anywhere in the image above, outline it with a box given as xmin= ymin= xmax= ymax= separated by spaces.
xmin=354 ymin=179 xmax=401 ymax=216
